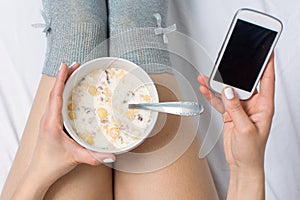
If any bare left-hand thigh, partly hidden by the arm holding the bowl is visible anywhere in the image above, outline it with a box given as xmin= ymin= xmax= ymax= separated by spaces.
xmin=1 ymin=75 xmax=112 ymax=200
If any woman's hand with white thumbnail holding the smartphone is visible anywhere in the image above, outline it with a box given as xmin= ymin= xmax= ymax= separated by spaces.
xmin=198 ymin=55 xmax=275 ymax=198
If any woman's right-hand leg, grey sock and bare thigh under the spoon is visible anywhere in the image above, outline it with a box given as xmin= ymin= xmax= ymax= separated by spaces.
xmin=108 ymin=0 xmax=217 ymax=197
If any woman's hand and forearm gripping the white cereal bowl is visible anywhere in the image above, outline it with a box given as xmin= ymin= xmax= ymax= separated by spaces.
xmin=11 ymin=64 xmax=115 ymax=199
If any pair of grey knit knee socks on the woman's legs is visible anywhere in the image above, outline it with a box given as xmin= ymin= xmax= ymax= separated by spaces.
xmin=43 ymin=0 xmax=170 ymax=76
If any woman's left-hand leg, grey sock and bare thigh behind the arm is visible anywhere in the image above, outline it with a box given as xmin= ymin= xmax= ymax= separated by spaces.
xmin=1 ymin=0 xmax=113 ymax=200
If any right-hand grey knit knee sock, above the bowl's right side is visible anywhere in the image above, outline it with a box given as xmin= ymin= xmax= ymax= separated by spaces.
xmin=108 ymin=0 xmax=171 ymax=73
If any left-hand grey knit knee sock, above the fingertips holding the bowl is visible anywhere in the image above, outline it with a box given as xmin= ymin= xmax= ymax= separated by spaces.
xmin=42 ymin=0 xmax=108 ymax=76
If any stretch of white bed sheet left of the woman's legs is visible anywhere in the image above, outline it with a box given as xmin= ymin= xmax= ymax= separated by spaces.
xmin=0 ymin=0 xmax=45 ymax=191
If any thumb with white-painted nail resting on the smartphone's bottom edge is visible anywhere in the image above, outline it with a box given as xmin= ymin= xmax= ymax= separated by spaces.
xmin=222 ymin=87 xmax=253 ymax=132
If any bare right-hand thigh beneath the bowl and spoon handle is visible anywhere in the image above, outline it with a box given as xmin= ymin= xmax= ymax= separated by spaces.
xmin=114 ymin=75 xmax=218 ymax=200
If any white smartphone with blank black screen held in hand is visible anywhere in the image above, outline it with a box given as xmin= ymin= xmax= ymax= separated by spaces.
xmin=209 ymin=8 xmax=282 ymax=100
